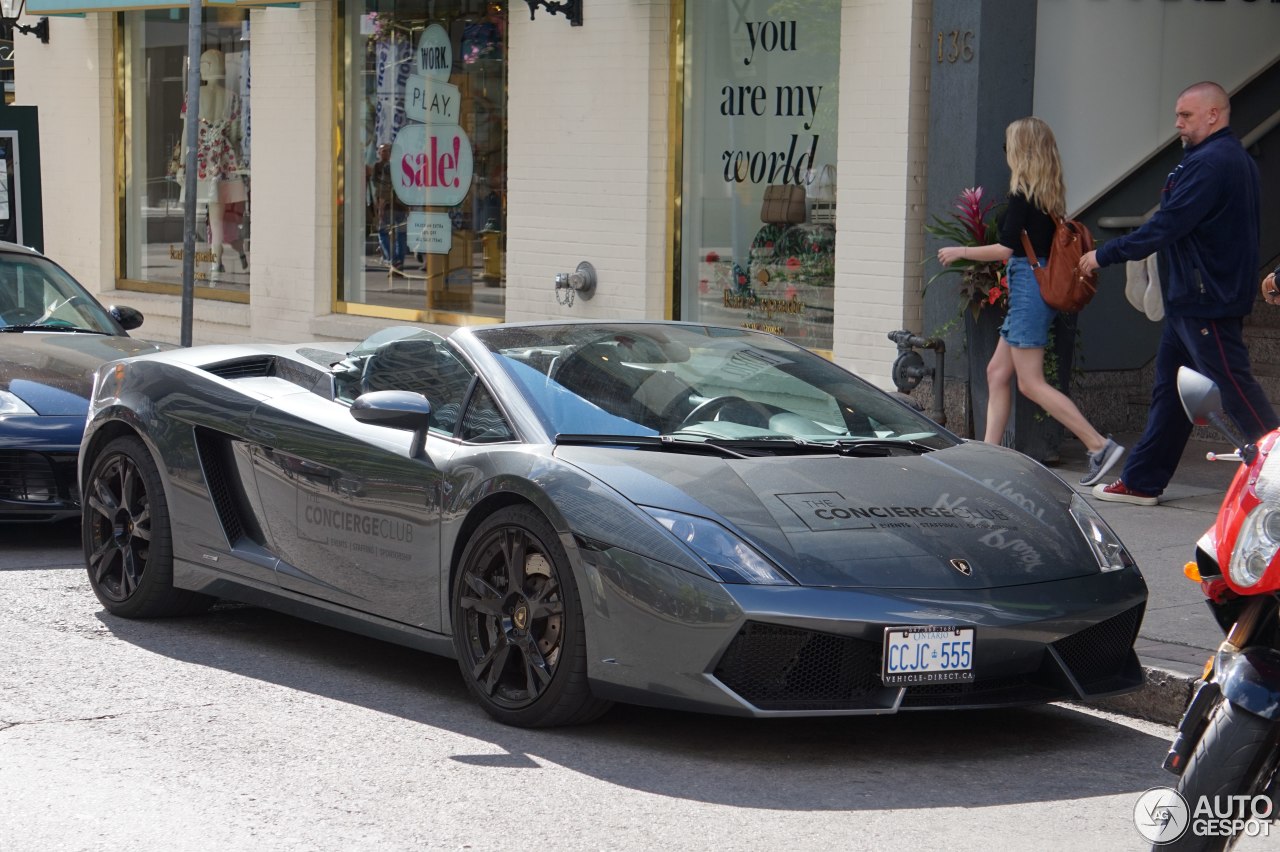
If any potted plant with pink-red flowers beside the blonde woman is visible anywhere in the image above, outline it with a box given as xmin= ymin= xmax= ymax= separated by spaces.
xmin=924 ymin=187 xmax=1009 ymax=319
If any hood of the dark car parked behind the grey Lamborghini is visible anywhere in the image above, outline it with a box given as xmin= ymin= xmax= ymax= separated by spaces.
xmin=0 ymin=331 xmax=161 ymax=417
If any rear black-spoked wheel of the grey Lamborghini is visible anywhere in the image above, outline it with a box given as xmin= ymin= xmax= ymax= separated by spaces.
xmin=81 ymin=436 xmax=214 ymax=618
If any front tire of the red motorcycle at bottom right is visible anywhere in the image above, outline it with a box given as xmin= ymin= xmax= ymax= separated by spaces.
xmin=1152 ymin=700 xmax=1280 ymax=852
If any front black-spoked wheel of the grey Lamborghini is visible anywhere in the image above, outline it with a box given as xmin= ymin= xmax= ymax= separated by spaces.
xmin=452 ymin=507 xmax=609 ymax=728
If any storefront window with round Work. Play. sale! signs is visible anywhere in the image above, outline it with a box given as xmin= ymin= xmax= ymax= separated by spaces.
xmin=339 ymin=0 xmax=507 ymax=319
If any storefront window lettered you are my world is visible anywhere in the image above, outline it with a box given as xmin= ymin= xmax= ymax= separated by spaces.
xmin=681 ymin=0 xmax=840 ymax=349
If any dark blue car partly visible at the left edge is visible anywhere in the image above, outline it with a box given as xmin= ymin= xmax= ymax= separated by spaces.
xmin=0 ymin=242 xmax=160 ymax=523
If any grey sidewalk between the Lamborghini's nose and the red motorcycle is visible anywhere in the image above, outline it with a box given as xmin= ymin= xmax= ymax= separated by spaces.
xmin=1052 ymin=432 xmax=1239 ymax=724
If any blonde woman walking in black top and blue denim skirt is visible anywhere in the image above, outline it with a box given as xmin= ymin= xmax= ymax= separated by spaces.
xmin=938 ymin=118 xmax=1124 ymax=485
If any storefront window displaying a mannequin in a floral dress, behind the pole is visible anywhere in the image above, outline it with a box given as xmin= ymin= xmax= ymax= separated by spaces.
xmin=120 ymin=9 xmax=252 ymax=299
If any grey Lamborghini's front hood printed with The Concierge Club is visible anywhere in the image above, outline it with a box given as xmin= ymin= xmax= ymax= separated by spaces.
xmin=557 ymin=443 xmax=1098 ymax=590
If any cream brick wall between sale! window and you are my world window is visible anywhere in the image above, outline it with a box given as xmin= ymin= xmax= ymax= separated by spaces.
xmin=507 ymin=0 xmax=671 ymax=320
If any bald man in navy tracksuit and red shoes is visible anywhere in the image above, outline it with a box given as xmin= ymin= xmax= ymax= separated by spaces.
xmin=1080 ymin=82 xmax=1277 ymax=505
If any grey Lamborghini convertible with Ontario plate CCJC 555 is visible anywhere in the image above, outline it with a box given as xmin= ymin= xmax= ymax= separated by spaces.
xmin=81 ymin=322 xmax=1147 ymax=725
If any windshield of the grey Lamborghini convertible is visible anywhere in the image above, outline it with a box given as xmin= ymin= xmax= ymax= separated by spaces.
xmin=475 ymin=324 xmax=955 ymax=448
